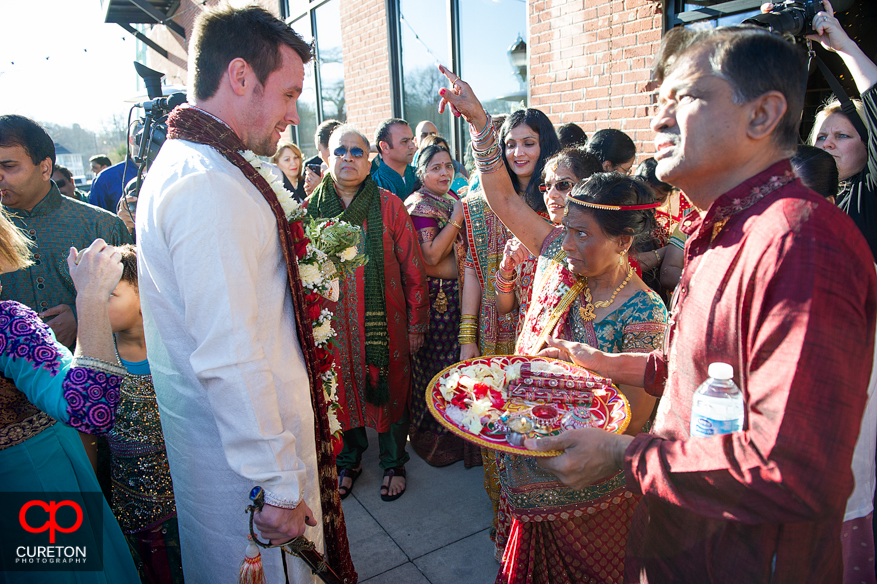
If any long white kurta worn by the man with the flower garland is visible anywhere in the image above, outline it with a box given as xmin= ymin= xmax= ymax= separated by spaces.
xmin=137 ymin=140 xmax=324 ymax=584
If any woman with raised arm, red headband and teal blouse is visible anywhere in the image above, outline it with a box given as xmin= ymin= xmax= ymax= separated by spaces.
xmin=440 ymin=68 xmax=667 ymax=584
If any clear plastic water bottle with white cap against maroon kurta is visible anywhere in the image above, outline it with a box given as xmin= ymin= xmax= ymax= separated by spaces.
xmin=691 ymin=363 xmax=746 ymax=438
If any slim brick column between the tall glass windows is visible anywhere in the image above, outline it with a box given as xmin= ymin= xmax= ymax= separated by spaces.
xmin=341 ymin=0 xmax=393 ymax=139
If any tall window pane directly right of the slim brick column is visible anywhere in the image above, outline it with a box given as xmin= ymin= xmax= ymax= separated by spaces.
xmin=399 ymin=0 xmax=451 ymax=141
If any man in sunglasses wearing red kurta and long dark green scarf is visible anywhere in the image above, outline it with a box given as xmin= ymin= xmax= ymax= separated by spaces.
xmin=308 ymin=125 xmax=429 ymax=501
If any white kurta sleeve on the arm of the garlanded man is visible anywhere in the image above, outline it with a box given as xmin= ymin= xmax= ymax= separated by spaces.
xmin=156 ymin=172 xmax=310 ymax=508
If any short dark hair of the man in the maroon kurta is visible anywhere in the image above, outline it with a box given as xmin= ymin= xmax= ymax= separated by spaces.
xmin=652 ymin=25 xmax=807 ymax=152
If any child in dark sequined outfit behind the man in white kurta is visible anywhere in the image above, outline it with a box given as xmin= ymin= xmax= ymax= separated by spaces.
xmin=107 ymin=245 xmax=183 ymax=584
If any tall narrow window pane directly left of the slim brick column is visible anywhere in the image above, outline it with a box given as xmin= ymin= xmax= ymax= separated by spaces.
xmin=314 ymin=0 xmax=347 ymax=122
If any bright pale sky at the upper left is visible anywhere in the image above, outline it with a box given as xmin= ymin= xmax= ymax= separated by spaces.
xmin=0 ymin=0 xmax=142 ymax=131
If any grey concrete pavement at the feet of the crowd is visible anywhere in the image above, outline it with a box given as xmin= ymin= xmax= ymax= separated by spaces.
xmin=343 ymin=429 xmax=499 ymax=584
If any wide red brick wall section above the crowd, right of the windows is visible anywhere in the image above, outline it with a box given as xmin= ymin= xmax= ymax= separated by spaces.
xmin=527 ymin=0 xmax=663 ymax=161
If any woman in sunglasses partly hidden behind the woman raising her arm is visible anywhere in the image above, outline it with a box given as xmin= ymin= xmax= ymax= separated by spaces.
xmin=495 ymin=147 xmax=603 ymax=334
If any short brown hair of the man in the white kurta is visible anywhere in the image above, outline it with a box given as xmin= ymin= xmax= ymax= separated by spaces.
xmin=189 ymin=6 xmax=312 ymax=100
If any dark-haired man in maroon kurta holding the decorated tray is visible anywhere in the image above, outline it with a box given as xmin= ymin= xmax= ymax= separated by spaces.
xmin=528 ymin=29 xmax=877 ymax=584
